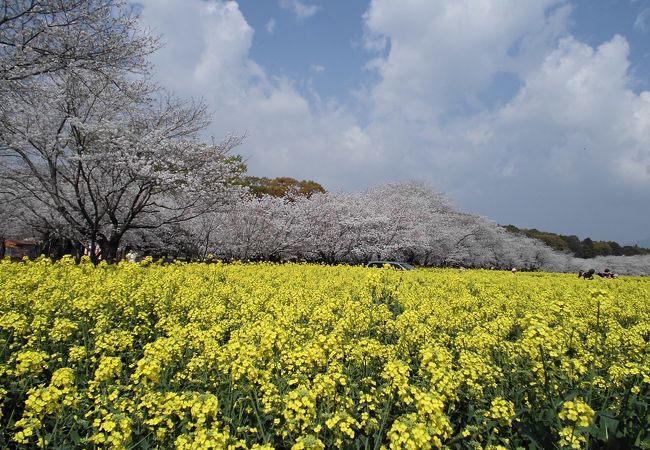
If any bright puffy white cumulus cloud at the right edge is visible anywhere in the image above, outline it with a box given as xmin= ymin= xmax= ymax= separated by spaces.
xmin=492 ymin=36 xmax=650 ymax=186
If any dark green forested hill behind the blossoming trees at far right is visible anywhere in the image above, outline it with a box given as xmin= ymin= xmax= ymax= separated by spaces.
xmin=504 ymin=225 xmax=650 ymax=258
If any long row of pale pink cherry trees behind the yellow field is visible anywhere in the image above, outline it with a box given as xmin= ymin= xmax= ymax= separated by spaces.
xmin=129 ymin=182 xmax=650 ymax=275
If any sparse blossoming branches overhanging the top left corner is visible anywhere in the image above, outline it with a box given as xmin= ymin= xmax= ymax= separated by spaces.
xmin=0 ymin=0 xmax=158 ymax=81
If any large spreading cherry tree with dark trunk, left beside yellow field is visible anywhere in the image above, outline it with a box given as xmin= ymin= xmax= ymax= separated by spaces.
xmin=0 ymin=72 xmax=243 ymax=260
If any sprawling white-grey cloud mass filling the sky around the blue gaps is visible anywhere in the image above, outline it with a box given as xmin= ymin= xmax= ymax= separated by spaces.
xmin=137 ymin=0 xmax=650 ymax=238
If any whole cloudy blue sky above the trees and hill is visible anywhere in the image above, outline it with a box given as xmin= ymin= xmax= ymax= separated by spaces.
xmin=137 ymin=0 xmax=650 ymax=243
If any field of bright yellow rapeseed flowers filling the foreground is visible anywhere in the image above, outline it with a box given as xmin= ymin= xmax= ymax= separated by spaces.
xmin=0 ymin=259 xmax=650 ymax=449
